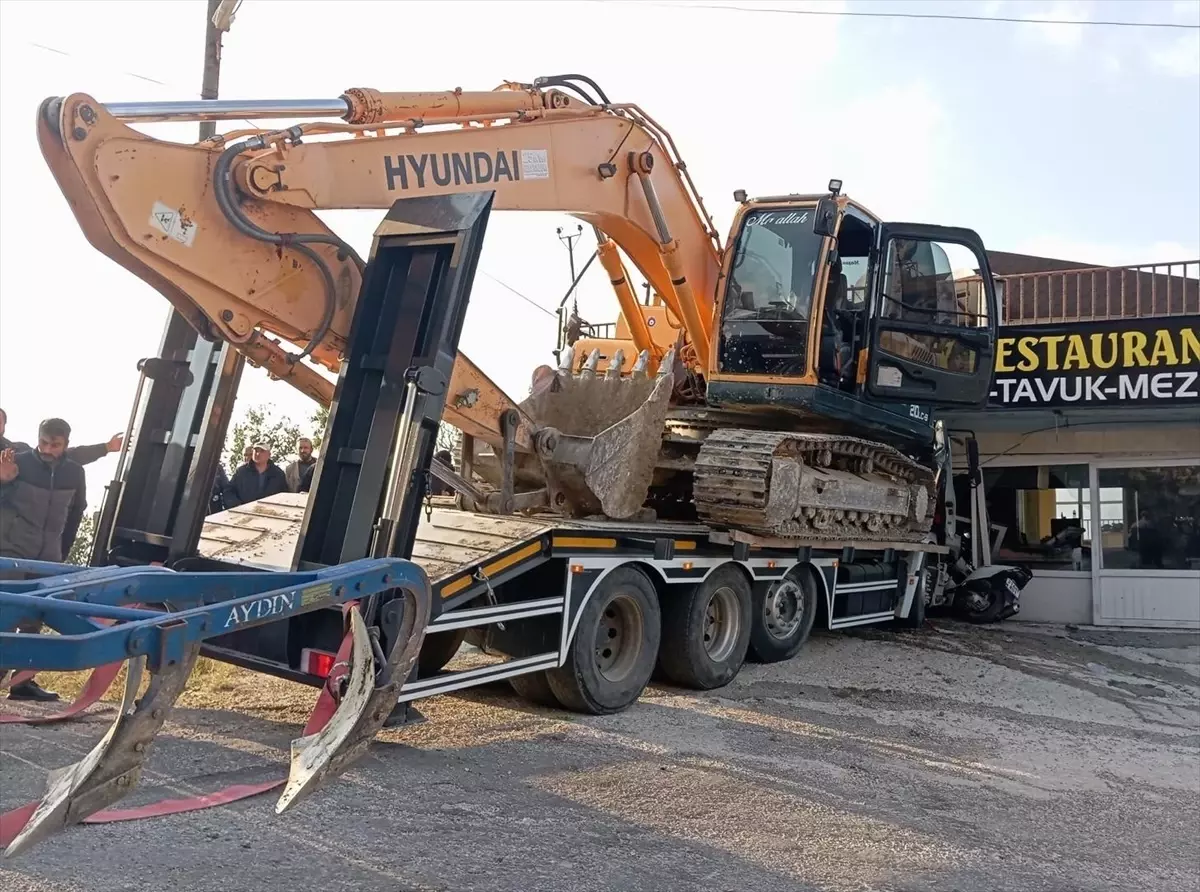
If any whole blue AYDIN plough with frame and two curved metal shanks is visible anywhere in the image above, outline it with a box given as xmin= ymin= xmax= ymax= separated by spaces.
xmin=0 ymin=558 xmax=432 ymax=857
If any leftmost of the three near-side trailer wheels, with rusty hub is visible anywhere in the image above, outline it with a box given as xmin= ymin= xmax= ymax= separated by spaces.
xmin=546 ymin=567 xmax=662 ymax=716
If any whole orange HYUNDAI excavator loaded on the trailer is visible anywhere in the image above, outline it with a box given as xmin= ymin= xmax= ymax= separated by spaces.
xmin=38 ymin=76 xmax=997 ymax=541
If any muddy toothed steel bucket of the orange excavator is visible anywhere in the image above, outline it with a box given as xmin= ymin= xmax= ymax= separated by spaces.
xmin=520 ymin=348 xmax=676 ymax=520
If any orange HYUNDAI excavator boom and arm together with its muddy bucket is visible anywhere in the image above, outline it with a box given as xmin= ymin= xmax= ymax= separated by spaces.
xmin=37 ymin=84 xmax=720 ymax=516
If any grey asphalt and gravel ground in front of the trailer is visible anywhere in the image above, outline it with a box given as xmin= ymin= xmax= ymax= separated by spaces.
xmin=0 ymin=622 xmax=1200 ymax=892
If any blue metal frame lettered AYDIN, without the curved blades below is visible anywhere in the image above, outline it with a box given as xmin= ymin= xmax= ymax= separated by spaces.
xmin=0 ymin=558 xmax=428 ymax=672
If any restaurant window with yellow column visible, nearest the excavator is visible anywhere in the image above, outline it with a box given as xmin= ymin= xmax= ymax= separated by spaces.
xmin=979 ymin=465 xmax=1094 ymax=571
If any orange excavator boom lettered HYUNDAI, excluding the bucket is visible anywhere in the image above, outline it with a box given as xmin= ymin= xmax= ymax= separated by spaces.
xmin=38 ymin=85 xmax=720 ymax=402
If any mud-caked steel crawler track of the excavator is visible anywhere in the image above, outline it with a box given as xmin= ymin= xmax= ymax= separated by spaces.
xmin=692 ymin=430 xmax=936 ymax=541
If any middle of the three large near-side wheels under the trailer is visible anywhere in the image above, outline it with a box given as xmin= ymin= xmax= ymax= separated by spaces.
xmin=659 ymin=564 xmax=754 ymax=690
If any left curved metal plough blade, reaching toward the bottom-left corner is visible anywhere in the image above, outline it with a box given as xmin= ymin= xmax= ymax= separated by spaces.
xmin=5 ymin=643 xmax=200 ymax=857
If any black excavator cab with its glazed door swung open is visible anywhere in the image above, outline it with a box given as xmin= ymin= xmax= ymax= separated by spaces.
xmin=708 ymin=181 xmax=997 ymax=444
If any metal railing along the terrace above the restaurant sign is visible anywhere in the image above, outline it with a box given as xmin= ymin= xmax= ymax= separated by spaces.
xmin=988 ymin=261 xmax=1200 ymax=325
